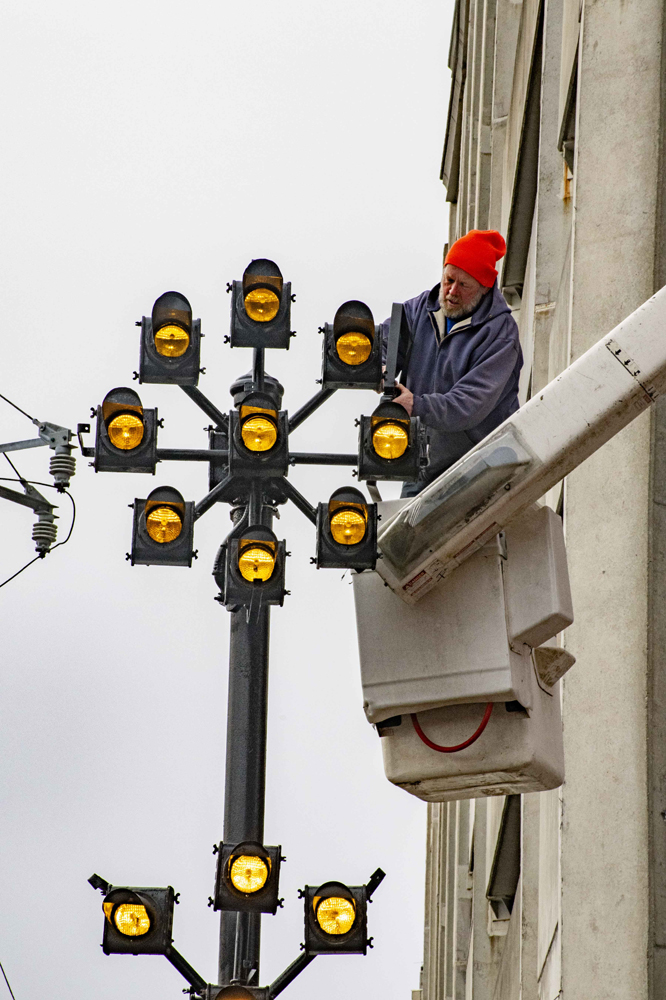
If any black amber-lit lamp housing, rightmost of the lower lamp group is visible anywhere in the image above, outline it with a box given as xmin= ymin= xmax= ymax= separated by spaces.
xmin=305 ymin=882 xmax=368 ymax=955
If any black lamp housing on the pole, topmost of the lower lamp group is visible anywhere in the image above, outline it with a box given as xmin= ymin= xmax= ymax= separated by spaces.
xmin=214 ymin=841 xmax=282 ymax=913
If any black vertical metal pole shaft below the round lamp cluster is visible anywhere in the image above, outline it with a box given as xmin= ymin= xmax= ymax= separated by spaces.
xmin=218 ymin=497 xmax=271 ymax=985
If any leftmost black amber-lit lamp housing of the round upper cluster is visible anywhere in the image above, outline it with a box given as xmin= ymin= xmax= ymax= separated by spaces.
xmin=94 ymin=388 xmax=157 ymax=475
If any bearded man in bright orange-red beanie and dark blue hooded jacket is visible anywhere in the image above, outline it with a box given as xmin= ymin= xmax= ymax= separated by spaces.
xmin=382 ymin=229 xmax=523 ymax=496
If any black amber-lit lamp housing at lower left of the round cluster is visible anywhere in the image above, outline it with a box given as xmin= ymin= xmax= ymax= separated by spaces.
xmin=132 ymin=486 xmax=194 ymax=566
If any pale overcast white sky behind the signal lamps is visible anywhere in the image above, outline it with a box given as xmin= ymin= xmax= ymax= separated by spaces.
xmin=0 ymin=0 xmax=453 ymax=1000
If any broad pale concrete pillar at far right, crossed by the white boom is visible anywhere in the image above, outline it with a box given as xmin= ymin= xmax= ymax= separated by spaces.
xmin=562 ymin=0 xmax=662 ymax=1000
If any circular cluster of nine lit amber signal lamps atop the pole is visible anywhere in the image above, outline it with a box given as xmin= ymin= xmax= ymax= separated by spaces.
xmin=85 ymin=274 xmax=427 ymax=584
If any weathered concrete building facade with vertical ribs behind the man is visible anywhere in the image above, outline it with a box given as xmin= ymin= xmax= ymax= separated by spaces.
xmin=414 ymin=0 xmax=666 ymax=1000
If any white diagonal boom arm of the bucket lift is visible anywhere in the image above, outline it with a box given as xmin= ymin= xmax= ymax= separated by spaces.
xmin=377 ymin=288 xmax=666 ymax=604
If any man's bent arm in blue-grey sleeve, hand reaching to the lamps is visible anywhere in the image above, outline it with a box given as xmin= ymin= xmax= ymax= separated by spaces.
xmin=410 ymin=340 xmax=518 ymax=432
